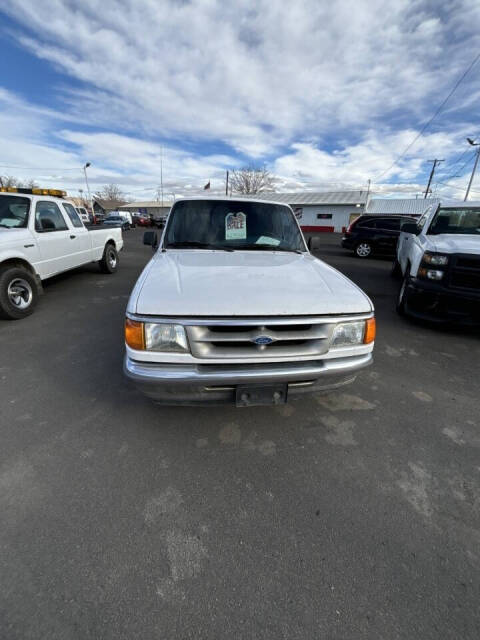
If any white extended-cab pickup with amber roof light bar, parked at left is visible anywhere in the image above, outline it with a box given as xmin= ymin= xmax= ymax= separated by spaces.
xmin=0 ymin=187 xmax=123 ymax=320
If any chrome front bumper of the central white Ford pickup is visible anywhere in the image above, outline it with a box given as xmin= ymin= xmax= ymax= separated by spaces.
xmin=124 ymin=352 xmax=373 ymax=405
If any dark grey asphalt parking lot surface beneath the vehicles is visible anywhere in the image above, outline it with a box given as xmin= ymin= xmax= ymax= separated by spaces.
xmin=0 ymin=230 xmax=480 ymax=640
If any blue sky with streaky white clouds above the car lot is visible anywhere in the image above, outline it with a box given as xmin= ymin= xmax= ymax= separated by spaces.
xmin=0 ymin=0 xmax=480 ymax=199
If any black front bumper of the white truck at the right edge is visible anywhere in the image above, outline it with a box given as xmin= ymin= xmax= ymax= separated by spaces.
xmin=405 ymin=278 xmax=480 ymax=326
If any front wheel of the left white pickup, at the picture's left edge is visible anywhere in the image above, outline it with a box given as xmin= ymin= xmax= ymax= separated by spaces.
xmin=0 ymin=266 xmax=38 ymax=320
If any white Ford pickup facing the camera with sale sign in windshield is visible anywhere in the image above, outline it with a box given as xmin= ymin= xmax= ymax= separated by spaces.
xmin=124 ymin=198 xmax=375 ymax=406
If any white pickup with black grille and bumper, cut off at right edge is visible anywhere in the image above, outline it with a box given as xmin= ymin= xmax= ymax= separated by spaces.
xmin=392 ymin=202 xmax=480 ymax=325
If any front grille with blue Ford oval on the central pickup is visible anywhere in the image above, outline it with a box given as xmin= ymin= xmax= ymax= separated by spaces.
xmin=185 ymin=320 xmax=333 ymax=358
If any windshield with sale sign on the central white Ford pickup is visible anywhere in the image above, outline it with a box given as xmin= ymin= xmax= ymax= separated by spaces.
xmin=164 ymin=200 xmax=305 ymax=251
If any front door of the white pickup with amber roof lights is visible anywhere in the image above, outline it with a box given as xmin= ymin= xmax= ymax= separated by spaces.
xmin=35 ymin=200 xmax=75 ymax=278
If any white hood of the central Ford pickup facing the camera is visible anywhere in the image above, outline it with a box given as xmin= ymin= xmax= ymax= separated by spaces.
xmin=133 ymin=250 xmax=373 ymax=317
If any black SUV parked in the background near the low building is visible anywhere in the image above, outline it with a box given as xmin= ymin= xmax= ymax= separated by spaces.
xmin=342 ymin=215 xmax=416 ymax=258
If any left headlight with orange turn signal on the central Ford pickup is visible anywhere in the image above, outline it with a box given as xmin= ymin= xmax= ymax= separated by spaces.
xmin=125 ymin=318 xmax=189 ymax=353
